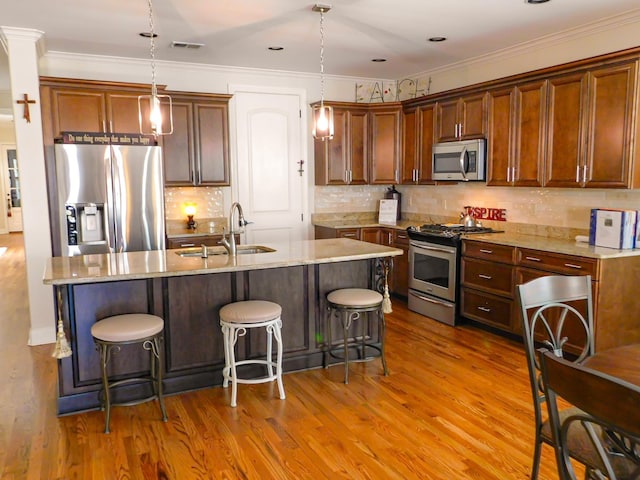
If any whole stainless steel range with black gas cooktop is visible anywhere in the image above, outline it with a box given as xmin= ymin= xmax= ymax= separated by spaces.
xmin=407 ymin=224 xmax=498 ymax=325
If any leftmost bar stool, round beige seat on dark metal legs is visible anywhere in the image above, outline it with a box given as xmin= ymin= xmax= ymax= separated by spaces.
xmin=91 ymin=313 xmax=167 ymax=433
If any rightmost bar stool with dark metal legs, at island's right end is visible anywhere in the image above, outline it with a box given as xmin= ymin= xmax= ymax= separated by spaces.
xmin=323 ymin=288 xmax=389 ymax=383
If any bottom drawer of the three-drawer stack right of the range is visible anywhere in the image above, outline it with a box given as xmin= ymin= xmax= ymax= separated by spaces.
xmin=461 ymin=288 xmax=514 ymax=332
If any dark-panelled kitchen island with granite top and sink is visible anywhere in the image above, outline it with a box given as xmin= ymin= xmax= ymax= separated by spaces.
xmin=43 ymin=239 xmax=402 ymax=414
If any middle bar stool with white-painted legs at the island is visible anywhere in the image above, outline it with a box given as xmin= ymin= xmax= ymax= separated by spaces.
xmin=220 ymin=300 xmax=285 ymax=407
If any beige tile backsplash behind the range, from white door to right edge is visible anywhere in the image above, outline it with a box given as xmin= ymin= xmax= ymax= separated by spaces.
xmin=314 ymin=183 xmax=640 ymax=232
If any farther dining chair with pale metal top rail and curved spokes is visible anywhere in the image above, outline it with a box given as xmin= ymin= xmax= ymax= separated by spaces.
xmin=517 ymin=275 xmax=594 ymax=480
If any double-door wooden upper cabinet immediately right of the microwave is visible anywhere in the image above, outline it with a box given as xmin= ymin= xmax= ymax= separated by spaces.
xmin=487 ymin=80 xmax=547 ymax=187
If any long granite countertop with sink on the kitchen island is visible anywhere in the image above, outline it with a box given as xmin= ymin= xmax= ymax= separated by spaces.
xmin=43 ymin=238 xmax=402 ymax=285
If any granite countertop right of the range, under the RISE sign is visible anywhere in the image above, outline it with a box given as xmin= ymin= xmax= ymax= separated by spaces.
xmin=463 ymin=232 xmax=640 ymax=258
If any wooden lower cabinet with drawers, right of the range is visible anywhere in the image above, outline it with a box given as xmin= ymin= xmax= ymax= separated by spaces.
xmin=461 ymin=240 xmax=640 ymax=352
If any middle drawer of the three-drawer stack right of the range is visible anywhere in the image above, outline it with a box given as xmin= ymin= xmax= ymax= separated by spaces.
xmin=462 ymin=258 xmax=515 ymax=297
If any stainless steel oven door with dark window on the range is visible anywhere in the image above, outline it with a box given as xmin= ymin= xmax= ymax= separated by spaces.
xmin=409 ymin=241 xmax=457 ymax=302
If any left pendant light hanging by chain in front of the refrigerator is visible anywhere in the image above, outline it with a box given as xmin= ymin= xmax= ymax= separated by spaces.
xmin=138 ymin=0 xmax=173 ymax=137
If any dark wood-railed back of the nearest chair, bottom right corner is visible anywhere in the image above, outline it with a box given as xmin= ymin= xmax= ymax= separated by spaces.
xmin=539 ymin=349 xmax=640 ymax=480
